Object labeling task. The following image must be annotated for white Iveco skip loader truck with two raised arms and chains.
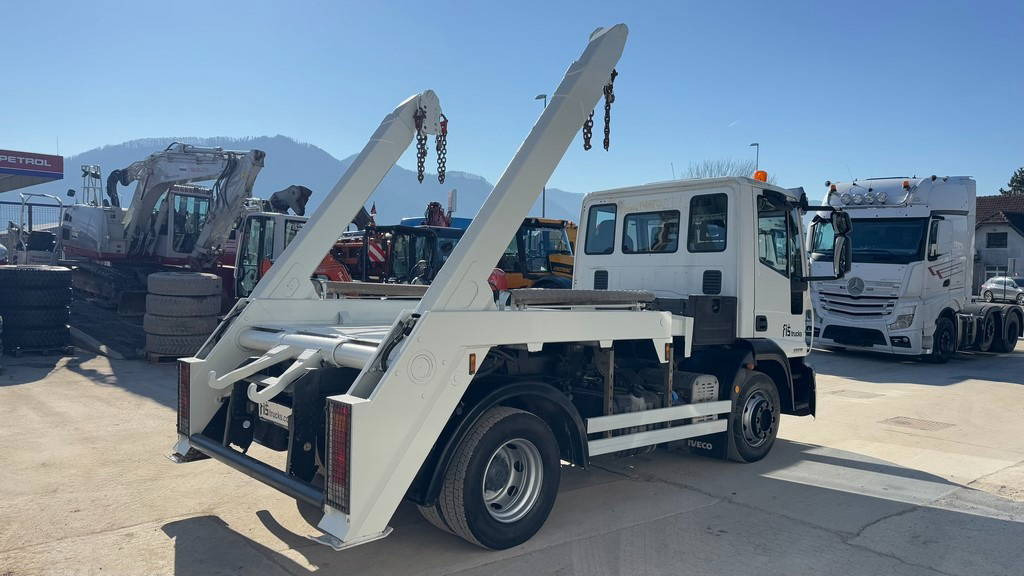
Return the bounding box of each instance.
[172,25,849,549]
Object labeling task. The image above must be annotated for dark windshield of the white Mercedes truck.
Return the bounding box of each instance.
[811,218,928,264]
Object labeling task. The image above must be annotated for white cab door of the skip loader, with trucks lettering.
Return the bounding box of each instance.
[754,191,808,355]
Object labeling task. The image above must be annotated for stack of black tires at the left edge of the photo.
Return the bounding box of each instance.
[0,265,72,354]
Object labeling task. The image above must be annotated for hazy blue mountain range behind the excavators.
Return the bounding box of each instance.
[0,135,583,223]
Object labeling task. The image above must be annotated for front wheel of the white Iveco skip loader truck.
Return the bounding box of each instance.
[729,370,781,462]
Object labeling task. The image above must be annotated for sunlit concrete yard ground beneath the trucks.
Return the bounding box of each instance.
[0,347,1024,576]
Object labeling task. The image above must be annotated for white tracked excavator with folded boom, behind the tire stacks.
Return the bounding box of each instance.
[61,142,311,312]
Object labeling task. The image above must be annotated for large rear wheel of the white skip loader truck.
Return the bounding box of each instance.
[438,406,561,550]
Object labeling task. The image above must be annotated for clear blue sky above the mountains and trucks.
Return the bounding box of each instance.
[0,0,1024,196]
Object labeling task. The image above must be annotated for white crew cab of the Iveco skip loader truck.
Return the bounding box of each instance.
[572,177,811,358]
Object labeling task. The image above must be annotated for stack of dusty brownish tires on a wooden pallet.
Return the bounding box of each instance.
[142,272,220,359]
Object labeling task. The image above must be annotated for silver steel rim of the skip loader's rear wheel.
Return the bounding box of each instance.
[480,438,544,524]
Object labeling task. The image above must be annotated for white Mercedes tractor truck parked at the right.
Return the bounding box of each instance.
[808,176,1024,362]
